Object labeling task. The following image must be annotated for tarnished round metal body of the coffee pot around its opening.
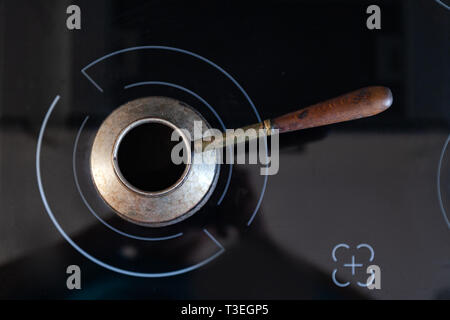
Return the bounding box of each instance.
[90,97,219,227]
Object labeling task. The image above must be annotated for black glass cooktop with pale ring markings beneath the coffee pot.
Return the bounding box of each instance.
[0,0,450,299]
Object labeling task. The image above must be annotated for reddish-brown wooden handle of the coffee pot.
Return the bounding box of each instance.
[271,87,392,133]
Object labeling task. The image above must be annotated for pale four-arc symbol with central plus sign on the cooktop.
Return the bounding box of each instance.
[331,243,381,289]
